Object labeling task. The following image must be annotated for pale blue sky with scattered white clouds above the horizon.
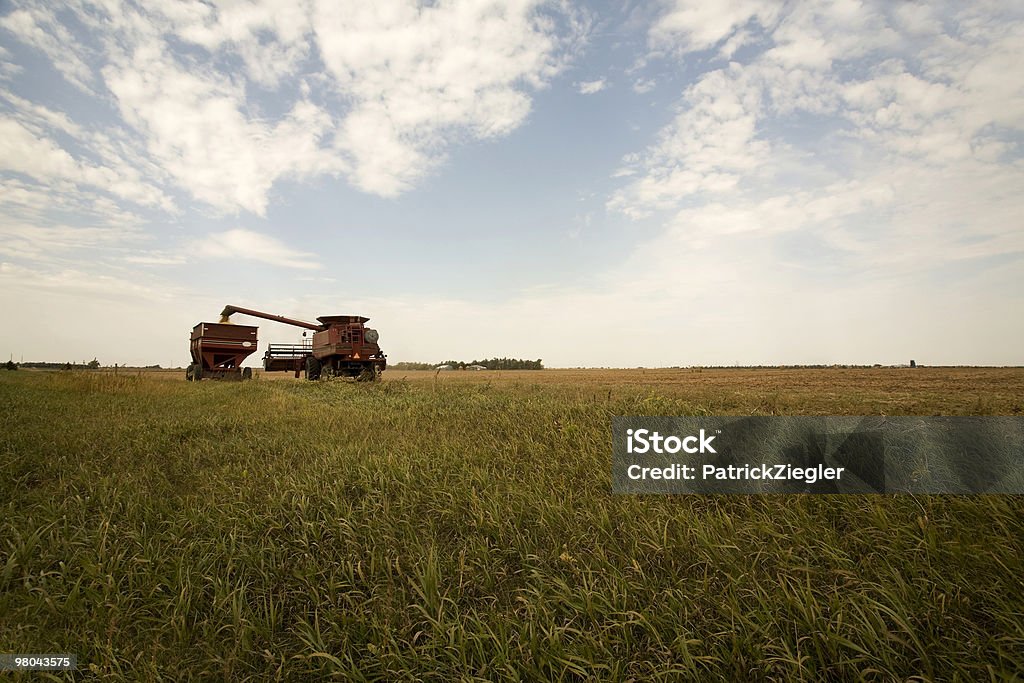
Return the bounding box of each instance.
[0,0,1024,368]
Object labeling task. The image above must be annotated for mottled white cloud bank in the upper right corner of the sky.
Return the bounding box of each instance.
[609,2,1024,223]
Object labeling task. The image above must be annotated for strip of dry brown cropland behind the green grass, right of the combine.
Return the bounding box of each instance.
[385,368,1024,415]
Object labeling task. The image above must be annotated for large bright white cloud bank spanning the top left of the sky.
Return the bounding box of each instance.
[0,0,586,215]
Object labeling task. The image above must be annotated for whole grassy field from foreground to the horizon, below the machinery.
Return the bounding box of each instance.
[0,368,1024,681]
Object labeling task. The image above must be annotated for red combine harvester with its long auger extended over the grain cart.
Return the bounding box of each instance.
[220,306,387,382]
